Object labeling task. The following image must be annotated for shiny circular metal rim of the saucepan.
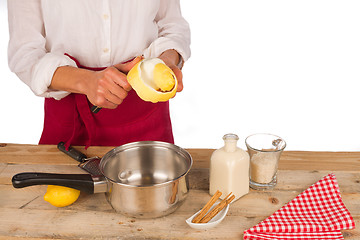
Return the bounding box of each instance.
[99,141,193,188]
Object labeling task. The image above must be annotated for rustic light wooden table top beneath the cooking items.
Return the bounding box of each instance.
[0,144,360,240]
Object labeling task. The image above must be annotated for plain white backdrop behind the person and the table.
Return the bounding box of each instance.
[0,0,360,151]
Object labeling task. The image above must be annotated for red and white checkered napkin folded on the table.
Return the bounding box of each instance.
[244,174,355,240]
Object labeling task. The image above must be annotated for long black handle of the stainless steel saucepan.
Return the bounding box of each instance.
[12,172,94,194]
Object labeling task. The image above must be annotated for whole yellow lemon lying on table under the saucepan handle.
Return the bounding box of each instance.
[44,185,80,207]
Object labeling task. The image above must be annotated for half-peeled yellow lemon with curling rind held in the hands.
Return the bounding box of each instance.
[127,58,178,103]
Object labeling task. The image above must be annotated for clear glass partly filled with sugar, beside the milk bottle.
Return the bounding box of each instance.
[245,133,286,190]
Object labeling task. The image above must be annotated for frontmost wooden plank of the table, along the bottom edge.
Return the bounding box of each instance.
[0,208,360,239]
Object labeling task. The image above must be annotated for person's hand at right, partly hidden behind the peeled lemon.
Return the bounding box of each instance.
[159,49,184,92]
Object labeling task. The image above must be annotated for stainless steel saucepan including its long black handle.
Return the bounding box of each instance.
[12,141,192,218]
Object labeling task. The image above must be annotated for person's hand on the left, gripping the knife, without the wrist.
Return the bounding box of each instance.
[85,57,141,109]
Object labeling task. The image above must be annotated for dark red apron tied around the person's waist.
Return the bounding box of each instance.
[39,56,174,148]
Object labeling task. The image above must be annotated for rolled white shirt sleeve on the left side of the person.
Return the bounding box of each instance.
[7,0,76,99]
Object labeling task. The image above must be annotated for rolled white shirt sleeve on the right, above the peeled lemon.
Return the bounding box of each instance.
[144,0,191,61]
